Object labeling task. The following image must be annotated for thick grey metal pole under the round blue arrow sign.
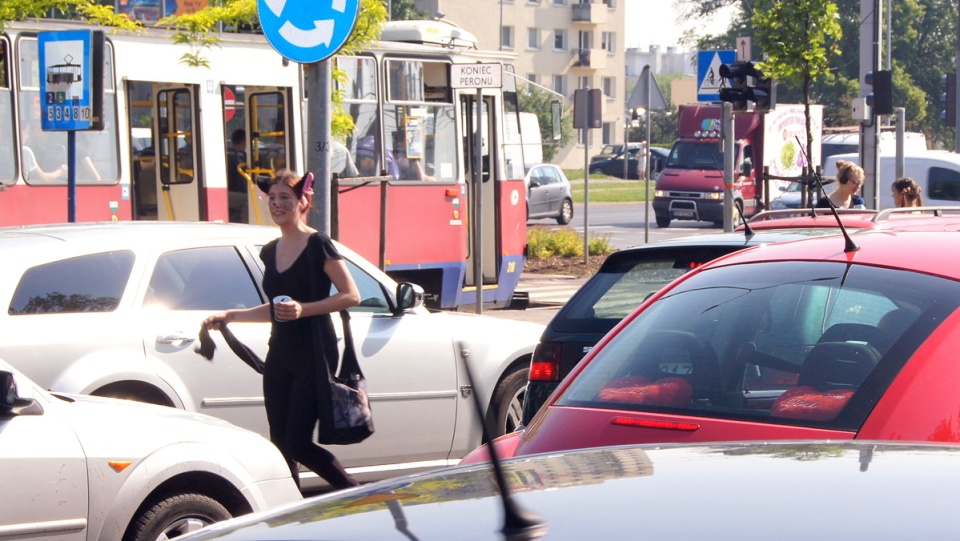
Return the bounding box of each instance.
[312,60,333,235]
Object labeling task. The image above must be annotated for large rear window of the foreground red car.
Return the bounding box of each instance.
[557,262,960,430]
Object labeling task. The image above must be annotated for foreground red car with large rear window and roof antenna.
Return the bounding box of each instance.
[464,230,960,462]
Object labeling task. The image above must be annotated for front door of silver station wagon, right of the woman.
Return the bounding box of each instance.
[333,260,465,467]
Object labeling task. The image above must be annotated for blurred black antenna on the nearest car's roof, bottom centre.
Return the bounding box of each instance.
[457,342,547,541]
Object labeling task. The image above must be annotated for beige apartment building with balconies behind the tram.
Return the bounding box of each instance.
[416,0,626,168]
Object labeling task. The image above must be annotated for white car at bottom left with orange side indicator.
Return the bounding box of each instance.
[0,361,301,541]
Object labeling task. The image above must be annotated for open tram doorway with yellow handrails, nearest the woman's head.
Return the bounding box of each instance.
[223,86,297,224]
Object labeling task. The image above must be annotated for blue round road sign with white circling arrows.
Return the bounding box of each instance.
[257,0,360,64]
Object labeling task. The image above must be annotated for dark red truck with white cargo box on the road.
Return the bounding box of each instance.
[653,104,823,227]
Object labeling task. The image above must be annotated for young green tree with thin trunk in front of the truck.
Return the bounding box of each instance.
[752,0,842,169]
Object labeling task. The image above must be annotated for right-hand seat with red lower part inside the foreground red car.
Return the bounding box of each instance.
[770,342,880,421]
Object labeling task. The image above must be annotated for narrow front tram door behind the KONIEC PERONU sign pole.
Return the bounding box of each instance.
[460,95,500,287]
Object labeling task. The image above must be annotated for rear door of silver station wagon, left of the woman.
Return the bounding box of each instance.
[139,242,270,435]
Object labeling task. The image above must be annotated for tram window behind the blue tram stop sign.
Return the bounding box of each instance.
[15,37,120,185]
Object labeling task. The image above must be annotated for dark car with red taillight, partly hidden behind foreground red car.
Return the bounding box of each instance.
[523,227,837,424]
